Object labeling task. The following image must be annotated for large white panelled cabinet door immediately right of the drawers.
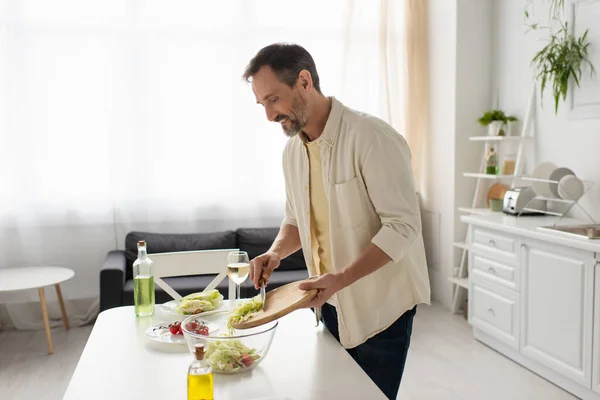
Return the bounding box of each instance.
[521,241,595,388]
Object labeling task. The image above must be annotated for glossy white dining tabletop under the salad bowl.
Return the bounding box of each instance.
[63,306,385,400]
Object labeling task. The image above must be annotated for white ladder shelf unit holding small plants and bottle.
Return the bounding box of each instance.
[448,83,536,314]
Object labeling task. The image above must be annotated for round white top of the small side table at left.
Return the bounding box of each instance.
[0,267,75,292]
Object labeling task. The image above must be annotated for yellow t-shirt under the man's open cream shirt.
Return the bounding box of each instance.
[306,139,335,305]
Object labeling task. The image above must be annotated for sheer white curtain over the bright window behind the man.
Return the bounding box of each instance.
[0,0,404,328]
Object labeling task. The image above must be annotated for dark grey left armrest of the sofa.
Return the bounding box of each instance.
[100,250,127,311]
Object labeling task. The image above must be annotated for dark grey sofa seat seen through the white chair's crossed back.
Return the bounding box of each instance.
[123,274,232,305]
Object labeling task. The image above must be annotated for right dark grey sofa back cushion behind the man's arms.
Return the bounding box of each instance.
[235,228,306,271]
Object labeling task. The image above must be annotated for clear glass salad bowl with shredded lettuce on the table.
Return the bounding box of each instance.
[181,313,278,374]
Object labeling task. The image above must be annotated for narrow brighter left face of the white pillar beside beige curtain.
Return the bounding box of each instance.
[422,0,456,304]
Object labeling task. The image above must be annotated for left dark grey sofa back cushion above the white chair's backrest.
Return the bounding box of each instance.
[125,231,238,279]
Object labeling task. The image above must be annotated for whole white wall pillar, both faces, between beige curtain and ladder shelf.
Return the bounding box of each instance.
[423,0,492,307]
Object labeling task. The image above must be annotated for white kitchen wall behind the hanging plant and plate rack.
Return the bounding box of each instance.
[493,0,600,221]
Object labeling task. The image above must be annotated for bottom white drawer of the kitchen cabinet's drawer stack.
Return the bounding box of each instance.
[469,284,519,349]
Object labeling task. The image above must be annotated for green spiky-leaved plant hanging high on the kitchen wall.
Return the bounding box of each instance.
[525,0,595,114]
